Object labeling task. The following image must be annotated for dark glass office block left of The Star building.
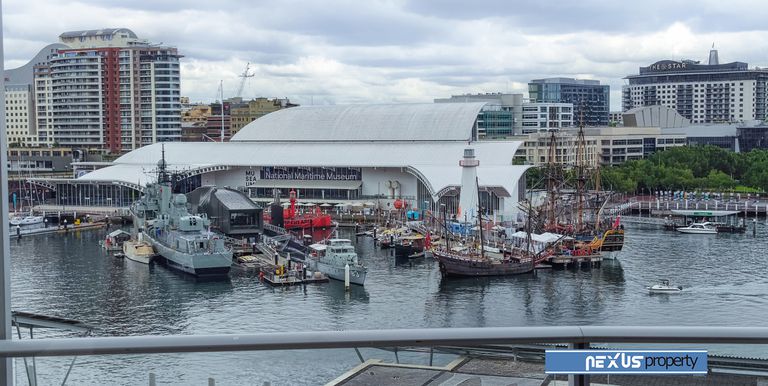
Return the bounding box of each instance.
[528,78,611,126]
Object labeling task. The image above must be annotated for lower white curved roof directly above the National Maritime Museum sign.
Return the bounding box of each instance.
[77,141,528,201]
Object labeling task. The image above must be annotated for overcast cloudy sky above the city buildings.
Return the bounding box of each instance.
[3,0,768,110]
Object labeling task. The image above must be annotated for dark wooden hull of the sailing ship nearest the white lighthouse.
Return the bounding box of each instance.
[433,251,533,277]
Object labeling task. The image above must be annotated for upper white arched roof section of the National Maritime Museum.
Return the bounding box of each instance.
[231,102,485,142]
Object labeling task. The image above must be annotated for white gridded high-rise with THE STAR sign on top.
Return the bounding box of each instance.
[621,49,768,123]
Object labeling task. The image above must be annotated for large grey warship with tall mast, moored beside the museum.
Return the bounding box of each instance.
[131,148,232,277]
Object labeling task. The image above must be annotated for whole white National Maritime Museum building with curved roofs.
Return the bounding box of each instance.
[35,103,529,218]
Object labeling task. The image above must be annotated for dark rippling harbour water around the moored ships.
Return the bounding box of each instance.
[11,223,768,385]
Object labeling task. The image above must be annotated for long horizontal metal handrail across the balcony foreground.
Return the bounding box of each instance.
[0,326,768,357]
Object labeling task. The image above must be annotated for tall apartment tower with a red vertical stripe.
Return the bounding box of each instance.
[24,28,181,153]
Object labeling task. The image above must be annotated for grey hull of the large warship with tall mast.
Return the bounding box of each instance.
[144,233,232,277]
